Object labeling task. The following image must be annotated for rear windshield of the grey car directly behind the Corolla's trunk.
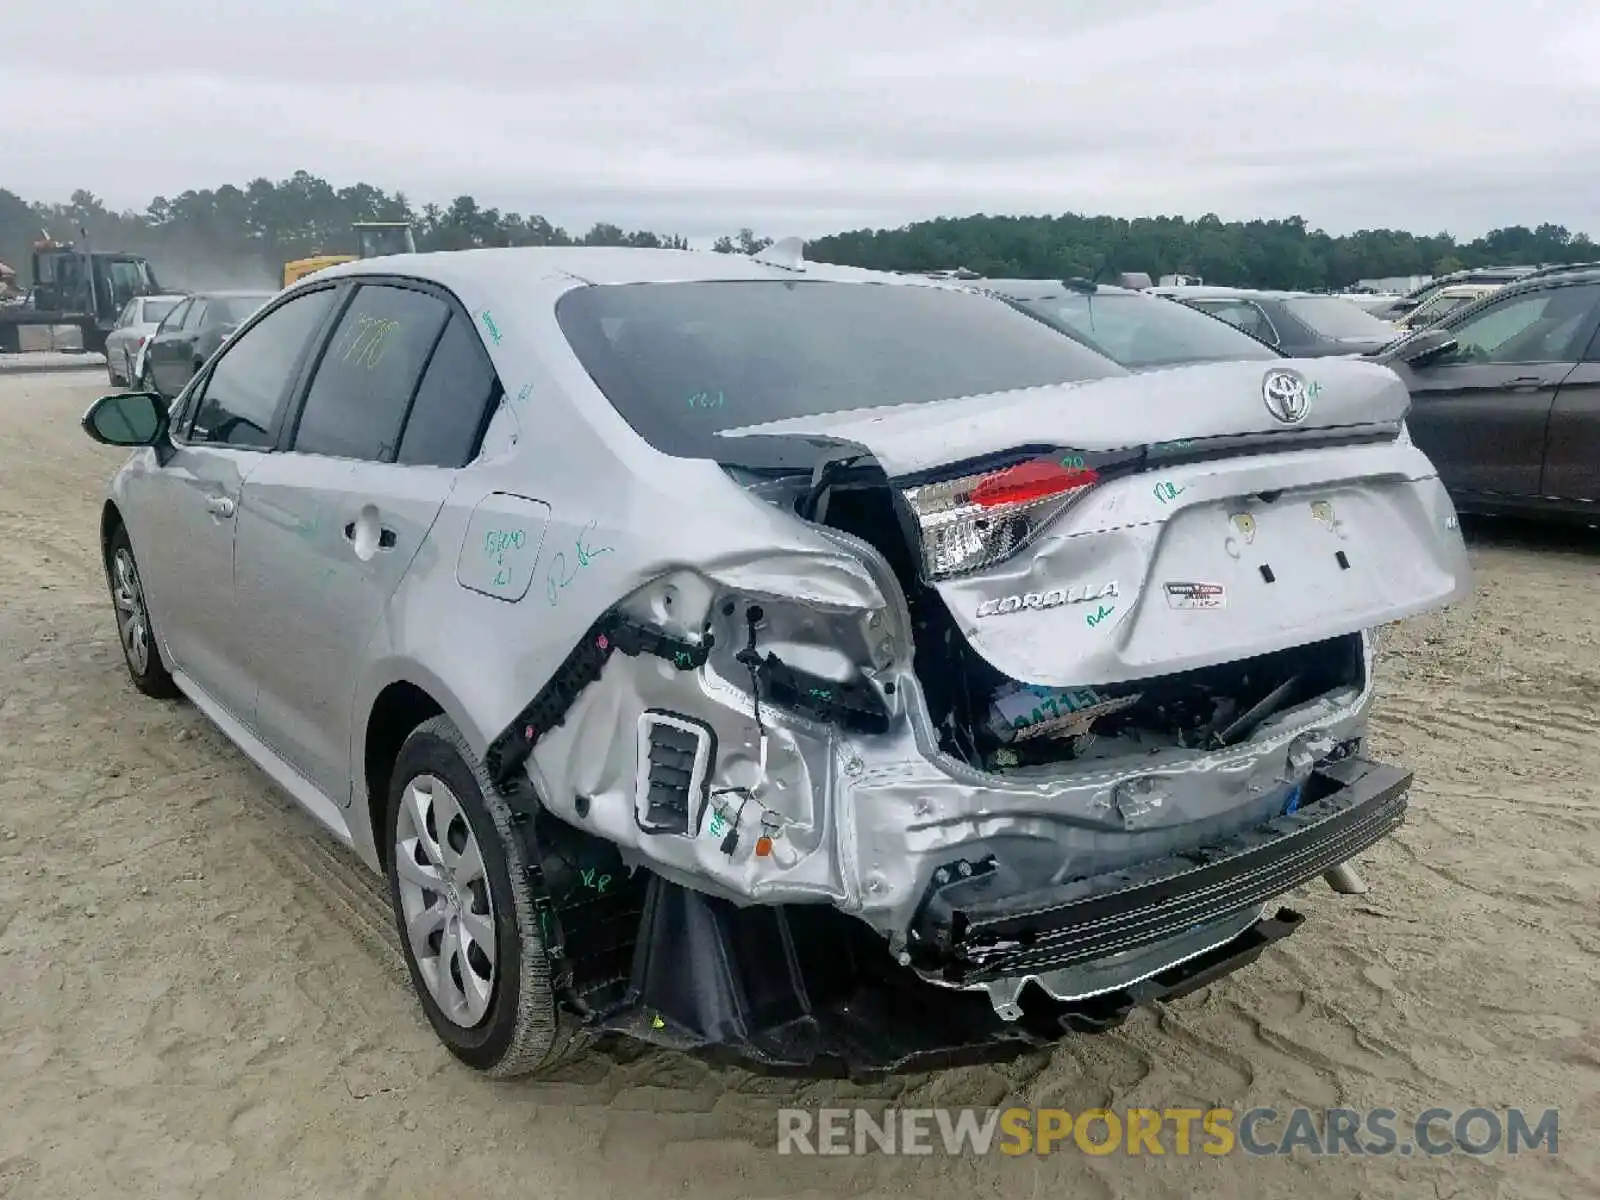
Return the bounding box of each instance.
[1019,293,1278,368]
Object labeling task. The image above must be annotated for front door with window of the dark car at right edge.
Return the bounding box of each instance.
[1395,285,1600,504]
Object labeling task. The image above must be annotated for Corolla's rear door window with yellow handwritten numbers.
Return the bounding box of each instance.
[293,285,450,462]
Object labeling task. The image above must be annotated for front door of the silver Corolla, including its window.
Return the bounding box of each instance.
[130,290,342,722]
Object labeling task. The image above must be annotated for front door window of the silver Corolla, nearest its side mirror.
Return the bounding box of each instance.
[189,288,334,450]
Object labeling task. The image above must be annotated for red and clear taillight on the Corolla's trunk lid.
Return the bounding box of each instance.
[902,454,1101,582]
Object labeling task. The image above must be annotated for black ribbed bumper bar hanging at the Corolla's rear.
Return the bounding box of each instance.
[909,758,1413,987]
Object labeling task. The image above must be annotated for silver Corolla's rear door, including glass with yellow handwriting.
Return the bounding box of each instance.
[237,280,496,805]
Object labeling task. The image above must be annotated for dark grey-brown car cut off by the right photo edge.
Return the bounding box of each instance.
[1378,267,1600,520]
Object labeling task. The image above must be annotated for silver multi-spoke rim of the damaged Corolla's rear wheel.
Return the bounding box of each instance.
[394,774,496,1029]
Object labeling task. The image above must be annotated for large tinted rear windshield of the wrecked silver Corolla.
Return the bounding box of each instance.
[555,280,1126,467]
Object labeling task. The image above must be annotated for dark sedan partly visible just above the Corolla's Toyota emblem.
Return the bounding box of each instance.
[1154,288,1395,358]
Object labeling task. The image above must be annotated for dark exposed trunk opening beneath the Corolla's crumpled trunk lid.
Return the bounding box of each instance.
[797,472,1363,771]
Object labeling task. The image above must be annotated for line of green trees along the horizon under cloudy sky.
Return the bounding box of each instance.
[0,171,1600,290]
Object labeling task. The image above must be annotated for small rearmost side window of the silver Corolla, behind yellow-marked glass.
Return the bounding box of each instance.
[395,314,499,467]
